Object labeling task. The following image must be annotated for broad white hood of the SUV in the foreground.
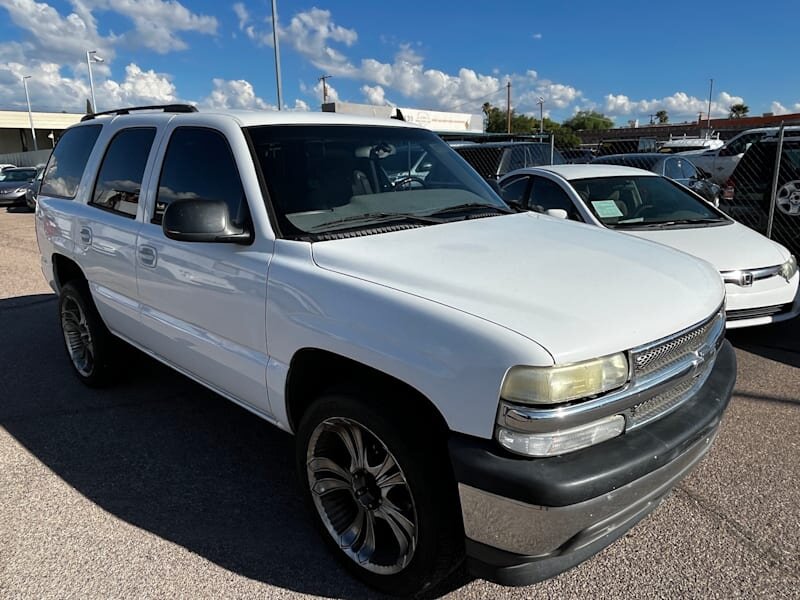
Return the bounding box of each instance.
[312,213,724,363]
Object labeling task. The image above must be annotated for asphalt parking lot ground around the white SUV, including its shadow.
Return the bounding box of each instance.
[0,207,800,600]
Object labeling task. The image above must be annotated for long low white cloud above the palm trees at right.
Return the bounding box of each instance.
[604,92,744,122]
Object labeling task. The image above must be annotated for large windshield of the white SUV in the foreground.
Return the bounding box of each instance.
[247,125,508,239]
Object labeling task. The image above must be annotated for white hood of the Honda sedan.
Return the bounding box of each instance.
[625,222,789,271]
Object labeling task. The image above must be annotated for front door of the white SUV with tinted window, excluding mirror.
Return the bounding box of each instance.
[136,124,273,413]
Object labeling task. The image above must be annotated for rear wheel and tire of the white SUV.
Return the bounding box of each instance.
[58,281,117,387]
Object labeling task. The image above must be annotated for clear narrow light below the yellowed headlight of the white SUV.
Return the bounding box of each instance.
[497,415,625,456]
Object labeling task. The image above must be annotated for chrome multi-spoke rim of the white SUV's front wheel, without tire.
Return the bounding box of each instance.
[306,417,417,575]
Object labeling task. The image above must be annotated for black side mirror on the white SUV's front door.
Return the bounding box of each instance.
[161,198,253,244]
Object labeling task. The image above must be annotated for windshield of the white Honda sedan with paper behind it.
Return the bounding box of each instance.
[570,176,730,229]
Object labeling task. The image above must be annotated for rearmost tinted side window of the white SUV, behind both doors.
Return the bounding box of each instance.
[40,125,102,199]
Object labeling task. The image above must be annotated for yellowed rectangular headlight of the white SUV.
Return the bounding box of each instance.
[500,352,628,404]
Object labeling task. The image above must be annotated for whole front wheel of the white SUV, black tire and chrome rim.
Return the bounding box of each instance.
[296,390,464,596]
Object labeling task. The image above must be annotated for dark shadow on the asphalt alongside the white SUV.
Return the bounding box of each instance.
[0,294,466,598]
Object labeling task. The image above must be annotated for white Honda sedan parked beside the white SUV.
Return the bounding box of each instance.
[499,165,800,329]
